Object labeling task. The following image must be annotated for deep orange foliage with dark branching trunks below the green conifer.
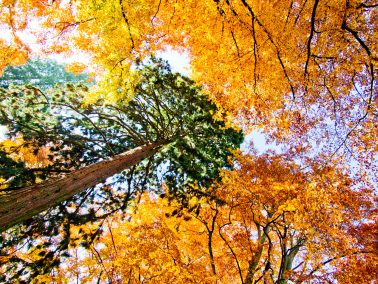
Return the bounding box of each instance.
[36,150,378,283]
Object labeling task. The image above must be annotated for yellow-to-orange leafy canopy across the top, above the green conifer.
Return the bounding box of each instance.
[2,0,378,166]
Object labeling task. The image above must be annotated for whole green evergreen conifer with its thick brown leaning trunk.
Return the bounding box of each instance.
[0,59,243,281]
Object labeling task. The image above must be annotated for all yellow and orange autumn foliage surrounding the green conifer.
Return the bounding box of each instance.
[0,0,378,283]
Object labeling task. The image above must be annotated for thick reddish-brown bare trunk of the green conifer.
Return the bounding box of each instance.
[0,142,164,232]
